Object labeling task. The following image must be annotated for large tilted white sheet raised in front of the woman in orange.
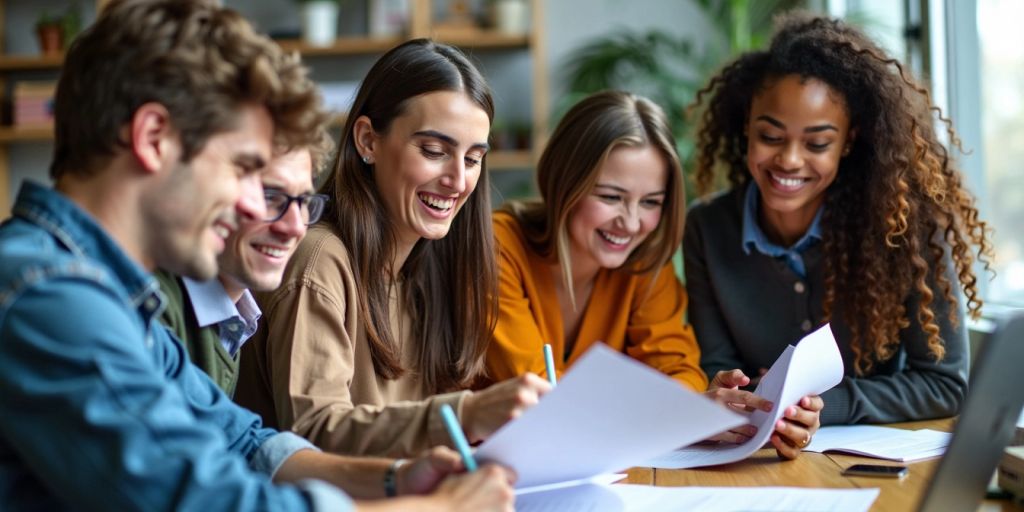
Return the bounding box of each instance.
[476,344,745,487]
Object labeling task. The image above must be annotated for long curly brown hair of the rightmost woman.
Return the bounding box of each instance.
[690,12,992,375]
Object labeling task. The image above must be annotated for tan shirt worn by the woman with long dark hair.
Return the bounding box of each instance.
[234,225,468,457]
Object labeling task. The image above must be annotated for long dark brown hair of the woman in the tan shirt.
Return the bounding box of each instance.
[321,39,498,393]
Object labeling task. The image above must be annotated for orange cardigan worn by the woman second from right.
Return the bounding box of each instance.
[486,212,708,391]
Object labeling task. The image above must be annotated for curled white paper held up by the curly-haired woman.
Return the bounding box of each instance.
[645,324,844,469]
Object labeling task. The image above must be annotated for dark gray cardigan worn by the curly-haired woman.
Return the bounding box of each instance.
[683,186,969,425]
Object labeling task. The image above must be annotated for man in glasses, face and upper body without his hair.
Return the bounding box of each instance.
[157,145,329,396]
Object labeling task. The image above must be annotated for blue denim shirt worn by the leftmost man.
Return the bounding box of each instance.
[0,183,351,512]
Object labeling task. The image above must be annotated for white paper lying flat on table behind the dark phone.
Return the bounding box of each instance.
[804,425,953,462]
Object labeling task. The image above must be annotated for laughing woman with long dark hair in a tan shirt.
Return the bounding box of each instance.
[237,39,549,457]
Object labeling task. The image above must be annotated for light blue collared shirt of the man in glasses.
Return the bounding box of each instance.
[181,278,263,356]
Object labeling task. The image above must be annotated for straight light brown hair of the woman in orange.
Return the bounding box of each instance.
[504,90,686,306]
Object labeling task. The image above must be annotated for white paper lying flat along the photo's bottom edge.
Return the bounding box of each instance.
[515,484,879,512]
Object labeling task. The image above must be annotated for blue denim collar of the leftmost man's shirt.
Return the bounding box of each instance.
[12,180,166,319]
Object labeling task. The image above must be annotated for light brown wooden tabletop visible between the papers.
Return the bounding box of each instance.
[625,419,1024,512]
